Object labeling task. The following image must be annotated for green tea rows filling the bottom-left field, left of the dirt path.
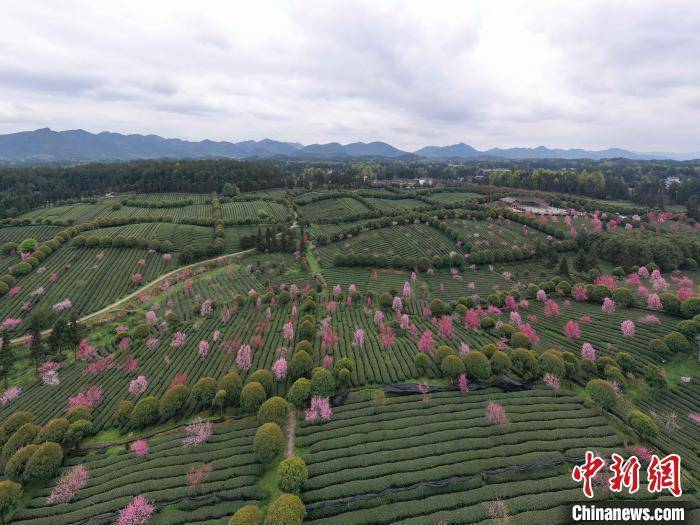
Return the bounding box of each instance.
[13,418,267,525]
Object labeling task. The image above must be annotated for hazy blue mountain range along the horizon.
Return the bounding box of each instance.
[0,128,700,163]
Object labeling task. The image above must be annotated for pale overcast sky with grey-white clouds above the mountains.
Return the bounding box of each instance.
[0,0,700,151]
